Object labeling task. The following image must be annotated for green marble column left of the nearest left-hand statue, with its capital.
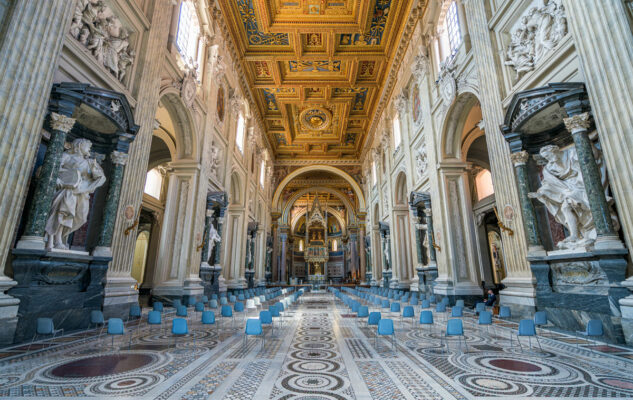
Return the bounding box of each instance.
[24,112,75,237]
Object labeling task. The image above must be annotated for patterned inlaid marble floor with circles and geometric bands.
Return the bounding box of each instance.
[0,294,633,400]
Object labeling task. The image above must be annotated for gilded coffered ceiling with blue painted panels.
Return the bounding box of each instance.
[219,0,412,160]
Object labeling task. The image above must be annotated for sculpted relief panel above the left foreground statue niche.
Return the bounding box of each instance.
[69,0,136,82]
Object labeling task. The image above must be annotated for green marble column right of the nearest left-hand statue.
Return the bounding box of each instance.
[92,150,128,257]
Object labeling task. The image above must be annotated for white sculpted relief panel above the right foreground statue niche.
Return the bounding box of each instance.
[505,0,567,79]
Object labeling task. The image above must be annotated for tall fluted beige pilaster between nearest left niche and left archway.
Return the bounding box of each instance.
[104,0,172,317]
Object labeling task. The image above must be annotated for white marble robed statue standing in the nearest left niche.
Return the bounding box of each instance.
[46,139,106,250]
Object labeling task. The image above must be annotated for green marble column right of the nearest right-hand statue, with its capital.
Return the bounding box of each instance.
[564,112,615,237]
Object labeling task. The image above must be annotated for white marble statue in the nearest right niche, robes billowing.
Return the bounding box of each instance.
[528,145,596,249]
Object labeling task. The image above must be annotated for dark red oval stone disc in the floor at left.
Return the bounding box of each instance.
[50,353,155,378]
